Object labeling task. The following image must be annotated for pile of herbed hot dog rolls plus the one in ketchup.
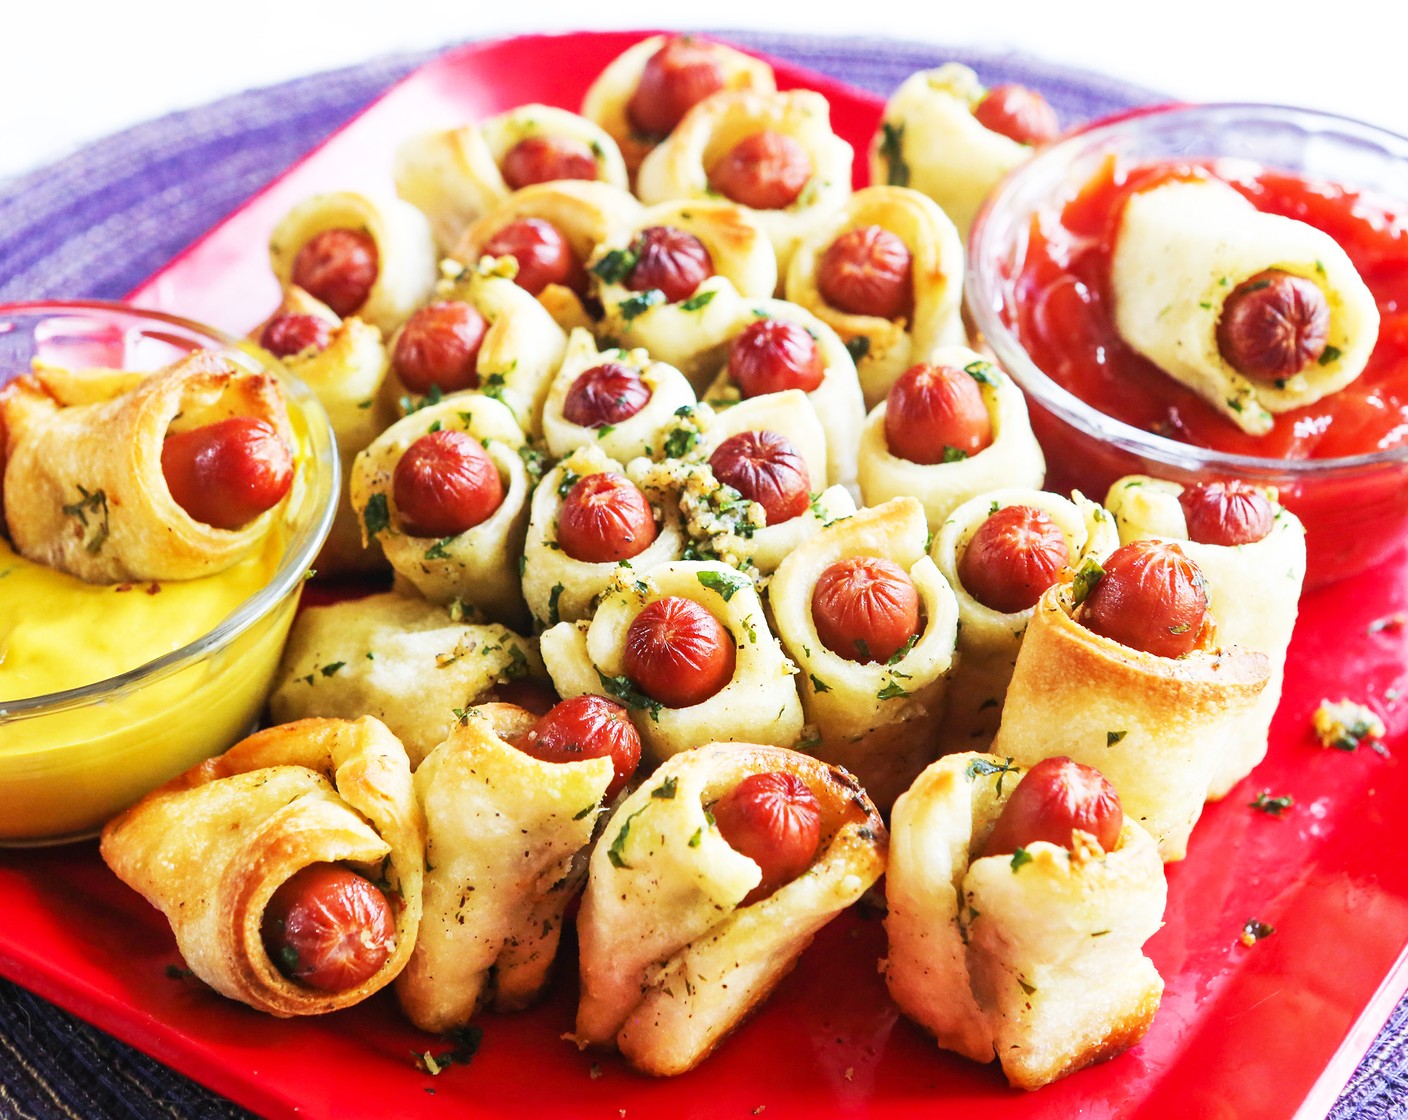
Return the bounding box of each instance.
[74,37,1373,1089]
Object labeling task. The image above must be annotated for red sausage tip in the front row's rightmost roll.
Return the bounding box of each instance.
[983,757,1125,855]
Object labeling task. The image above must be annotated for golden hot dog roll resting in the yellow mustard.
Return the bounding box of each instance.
[0,351,298,583]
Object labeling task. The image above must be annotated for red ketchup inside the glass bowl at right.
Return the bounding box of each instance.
[1004,158,1408,585]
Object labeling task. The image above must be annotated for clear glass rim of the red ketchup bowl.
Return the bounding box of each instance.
[963,101,1408,485]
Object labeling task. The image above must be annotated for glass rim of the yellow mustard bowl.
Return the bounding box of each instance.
[0,300,341,718]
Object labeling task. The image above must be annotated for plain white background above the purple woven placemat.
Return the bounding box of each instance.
[0,0,1408,180]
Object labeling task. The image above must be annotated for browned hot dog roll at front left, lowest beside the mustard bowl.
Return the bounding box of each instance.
[101,717,425,1016]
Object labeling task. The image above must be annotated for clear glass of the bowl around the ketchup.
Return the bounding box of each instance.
[964,104,1408,586]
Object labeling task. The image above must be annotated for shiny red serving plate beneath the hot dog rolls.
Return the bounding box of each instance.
[0,32,1408,1120]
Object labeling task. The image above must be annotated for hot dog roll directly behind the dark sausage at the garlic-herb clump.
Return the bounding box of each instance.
[704,300,865,490]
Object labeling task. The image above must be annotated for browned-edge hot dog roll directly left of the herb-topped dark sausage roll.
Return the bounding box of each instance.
[451,179,641,331]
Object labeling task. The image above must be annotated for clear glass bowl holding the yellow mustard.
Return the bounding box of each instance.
[0,301,338,847]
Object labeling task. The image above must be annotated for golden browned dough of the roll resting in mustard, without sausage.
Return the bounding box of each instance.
[0,351,297,583]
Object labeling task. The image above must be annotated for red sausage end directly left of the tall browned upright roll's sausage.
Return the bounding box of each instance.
[959,506,1070,614]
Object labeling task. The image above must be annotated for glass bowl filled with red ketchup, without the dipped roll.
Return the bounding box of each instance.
[966,106,1408,586]
